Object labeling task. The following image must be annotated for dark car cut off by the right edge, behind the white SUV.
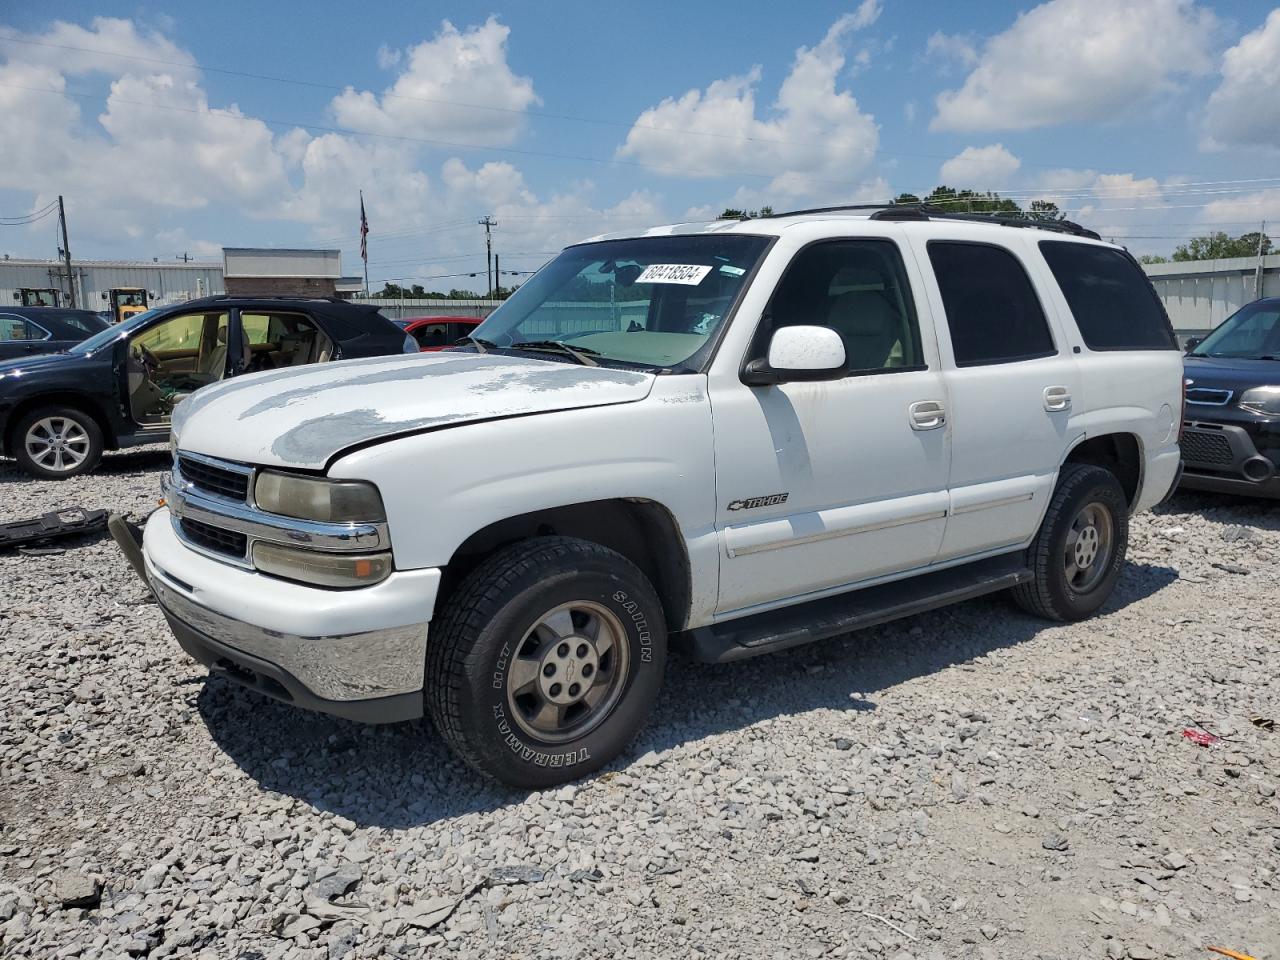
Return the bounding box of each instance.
[1181,297,1280,498]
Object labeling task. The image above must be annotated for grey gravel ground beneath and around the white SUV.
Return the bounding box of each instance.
[0,451,1280,960]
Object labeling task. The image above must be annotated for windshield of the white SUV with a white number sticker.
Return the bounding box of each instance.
[471,234,769,371]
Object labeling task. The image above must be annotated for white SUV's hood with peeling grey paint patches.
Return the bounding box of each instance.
[173,353,654,470]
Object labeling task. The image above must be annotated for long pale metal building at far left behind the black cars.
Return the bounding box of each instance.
[0,257,224,310]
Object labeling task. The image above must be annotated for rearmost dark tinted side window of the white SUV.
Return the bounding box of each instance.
[1039,241,1178,349]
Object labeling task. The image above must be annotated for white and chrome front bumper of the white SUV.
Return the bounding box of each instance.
[142,509,440,723]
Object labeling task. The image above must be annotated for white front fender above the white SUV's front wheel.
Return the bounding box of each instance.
[329,375,718,586]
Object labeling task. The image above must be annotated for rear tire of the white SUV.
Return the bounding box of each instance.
[1014,463,1129,621]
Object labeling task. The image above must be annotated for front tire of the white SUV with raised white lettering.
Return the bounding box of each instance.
[424,536,667,787]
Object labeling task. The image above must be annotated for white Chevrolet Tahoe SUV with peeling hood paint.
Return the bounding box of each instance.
[114,207,1183,786]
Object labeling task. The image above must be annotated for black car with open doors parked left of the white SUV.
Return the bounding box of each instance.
[0,297,417,480]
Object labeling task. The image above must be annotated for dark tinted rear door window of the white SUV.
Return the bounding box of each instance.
[929,241,1057,366]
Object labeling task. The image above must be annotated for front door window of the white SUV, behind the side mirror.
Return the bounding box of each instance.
[753,239,925,375]
